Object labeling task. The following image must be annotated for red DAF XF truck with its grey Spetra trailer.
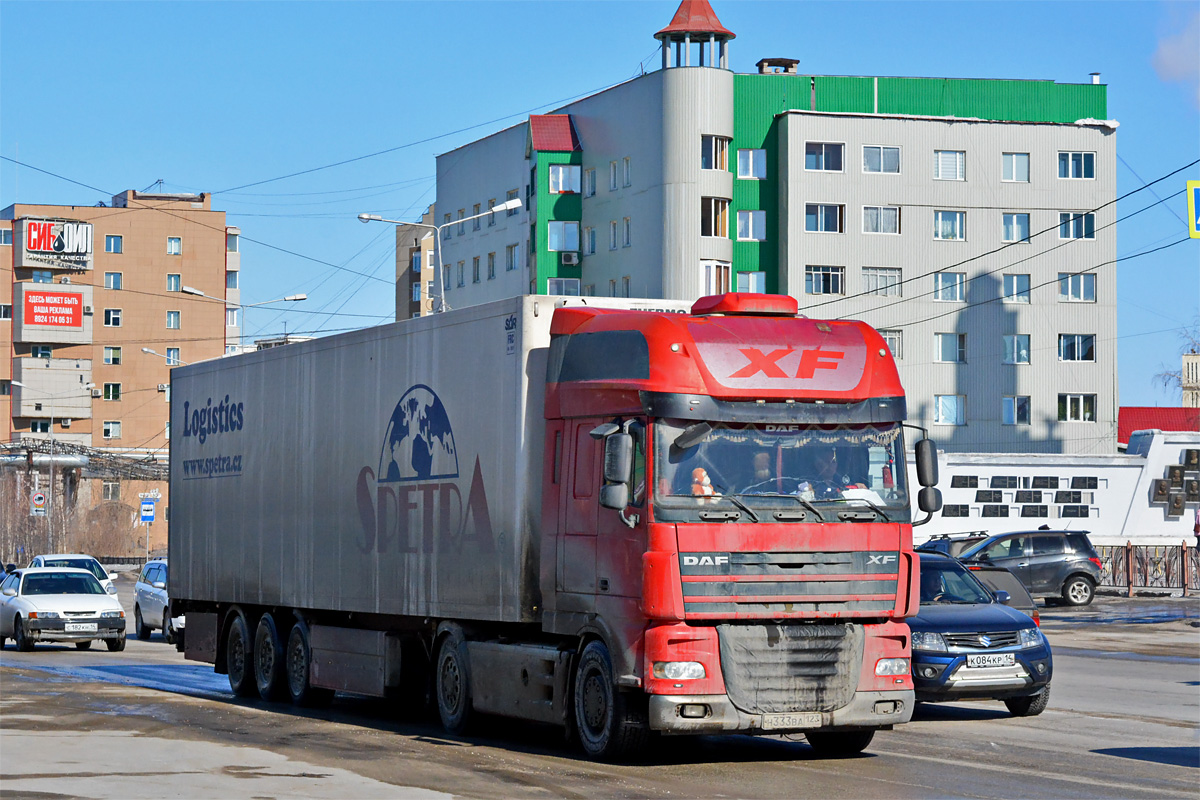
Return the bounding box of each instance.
[169,294,941,758]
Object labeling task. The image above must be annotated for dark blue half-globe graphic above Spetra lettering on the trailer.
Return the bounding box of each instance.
[378,385,458,483]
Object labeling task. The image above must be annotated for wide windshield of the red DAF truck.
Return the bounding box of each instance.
[654,420,910,522]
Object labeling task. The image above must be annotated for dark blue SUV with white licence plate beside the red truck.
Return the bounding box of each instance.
[908,553,1054,716]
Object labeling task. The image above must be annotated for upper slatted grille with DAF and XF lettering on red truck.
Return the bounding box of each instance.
[679,552,899,619]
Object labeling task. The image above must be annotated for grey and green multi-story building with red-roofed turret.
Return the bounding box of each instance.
[437,0,1117,452]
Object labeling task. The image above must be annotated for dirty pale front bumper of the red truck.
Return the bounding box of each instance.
[649,690,913,734]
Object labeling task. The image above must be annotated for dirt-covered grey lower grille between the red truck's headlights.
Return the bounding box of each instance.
[716,622,864,714]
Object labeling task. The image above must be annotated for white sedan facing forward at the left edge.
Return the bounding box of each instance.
[0,567,125,651]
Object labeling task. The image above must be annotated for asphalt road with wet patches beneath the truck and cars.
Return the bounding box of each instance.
[0,582,1200,799]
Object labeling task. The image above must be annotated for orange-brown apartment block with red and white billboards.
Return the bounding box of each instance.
[0,191,241,458]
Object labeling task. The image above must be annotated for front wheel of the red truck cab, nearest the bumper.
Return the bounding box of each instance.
[575,640,650,760]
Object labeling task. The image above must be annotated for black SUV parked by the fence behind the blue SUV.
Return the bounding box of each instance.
[959,530,1100,606]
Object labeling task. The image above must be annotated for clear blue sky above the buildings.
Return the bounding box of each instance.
[0,0,1200,405]
